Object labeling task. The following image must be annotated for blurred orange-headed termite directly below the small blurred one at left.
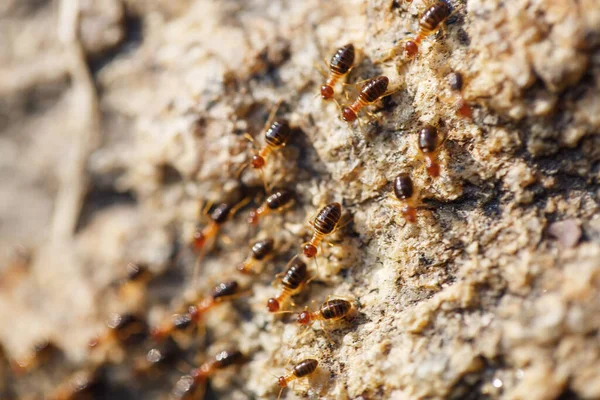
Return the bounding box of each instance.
[88,313,148,349]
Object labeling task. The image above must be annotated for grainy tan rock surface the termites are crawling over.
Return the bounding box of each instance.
[0,0,600,399]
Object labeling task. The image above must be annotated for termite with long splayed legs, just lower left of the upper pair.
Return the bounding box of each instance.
[237,101,292,193]
